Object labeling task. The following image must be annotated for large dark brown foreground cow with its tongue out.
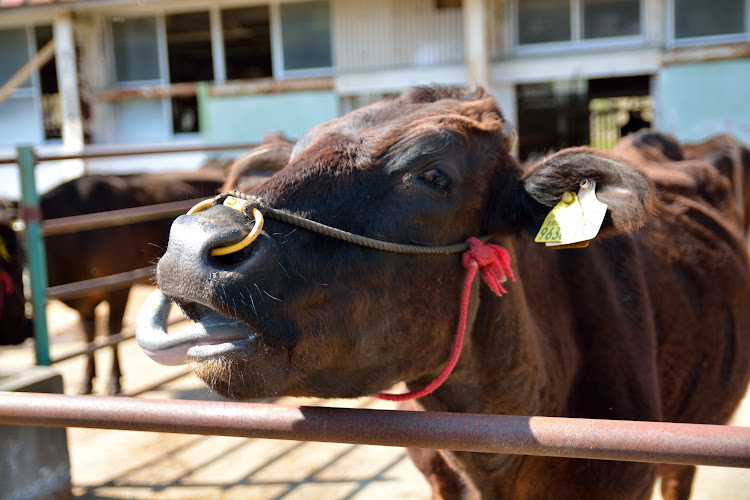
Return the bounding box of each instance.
[136,88,750,499]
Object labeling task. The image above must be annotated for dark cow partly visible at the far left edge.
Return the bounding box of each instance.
[0,211,33,345]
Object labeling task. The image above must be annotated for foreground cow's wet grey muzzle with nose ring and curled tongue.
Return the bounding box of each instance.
[136,200,263,365]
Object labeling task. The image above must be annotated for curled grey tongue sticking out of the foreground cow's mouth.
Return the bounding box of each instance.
[135,290,249,365]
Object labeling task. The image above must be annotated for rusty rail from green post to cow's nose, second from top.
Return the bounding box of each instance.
[42,197,208,236]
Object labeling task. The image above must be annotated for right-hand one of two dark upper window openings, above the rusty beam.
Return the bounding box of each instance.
[221,6,273,80]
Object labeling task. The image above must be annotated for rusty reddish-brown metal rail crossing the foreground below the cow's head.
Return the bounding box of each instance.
[0,393,750,468]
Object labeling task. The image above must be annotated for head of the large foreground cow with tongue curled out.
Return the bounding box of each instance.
[138,88,650,398]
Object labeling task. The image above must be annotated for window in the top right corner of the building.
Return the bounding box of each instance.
[674,0,747,38]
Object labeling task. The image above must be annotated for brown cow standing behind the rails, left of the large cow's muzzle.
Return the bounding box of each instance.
[41,171,223,394]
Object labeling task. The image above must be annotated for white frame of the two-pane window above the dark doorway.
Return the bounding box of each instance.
[510,0,648,55]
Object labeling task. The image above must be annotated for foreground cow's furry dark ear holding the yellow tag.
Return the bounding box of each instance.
[490,148,654,236]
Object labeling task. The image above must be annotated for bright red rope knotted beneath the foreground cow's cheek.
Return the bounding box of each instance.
[375,238,516,401]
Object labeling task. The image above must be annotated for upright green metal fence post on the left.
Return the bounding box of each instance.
[16,146,50,365]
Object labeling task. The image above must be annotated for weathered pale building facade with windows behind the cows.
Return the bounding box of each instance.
[0,0,750,196]
